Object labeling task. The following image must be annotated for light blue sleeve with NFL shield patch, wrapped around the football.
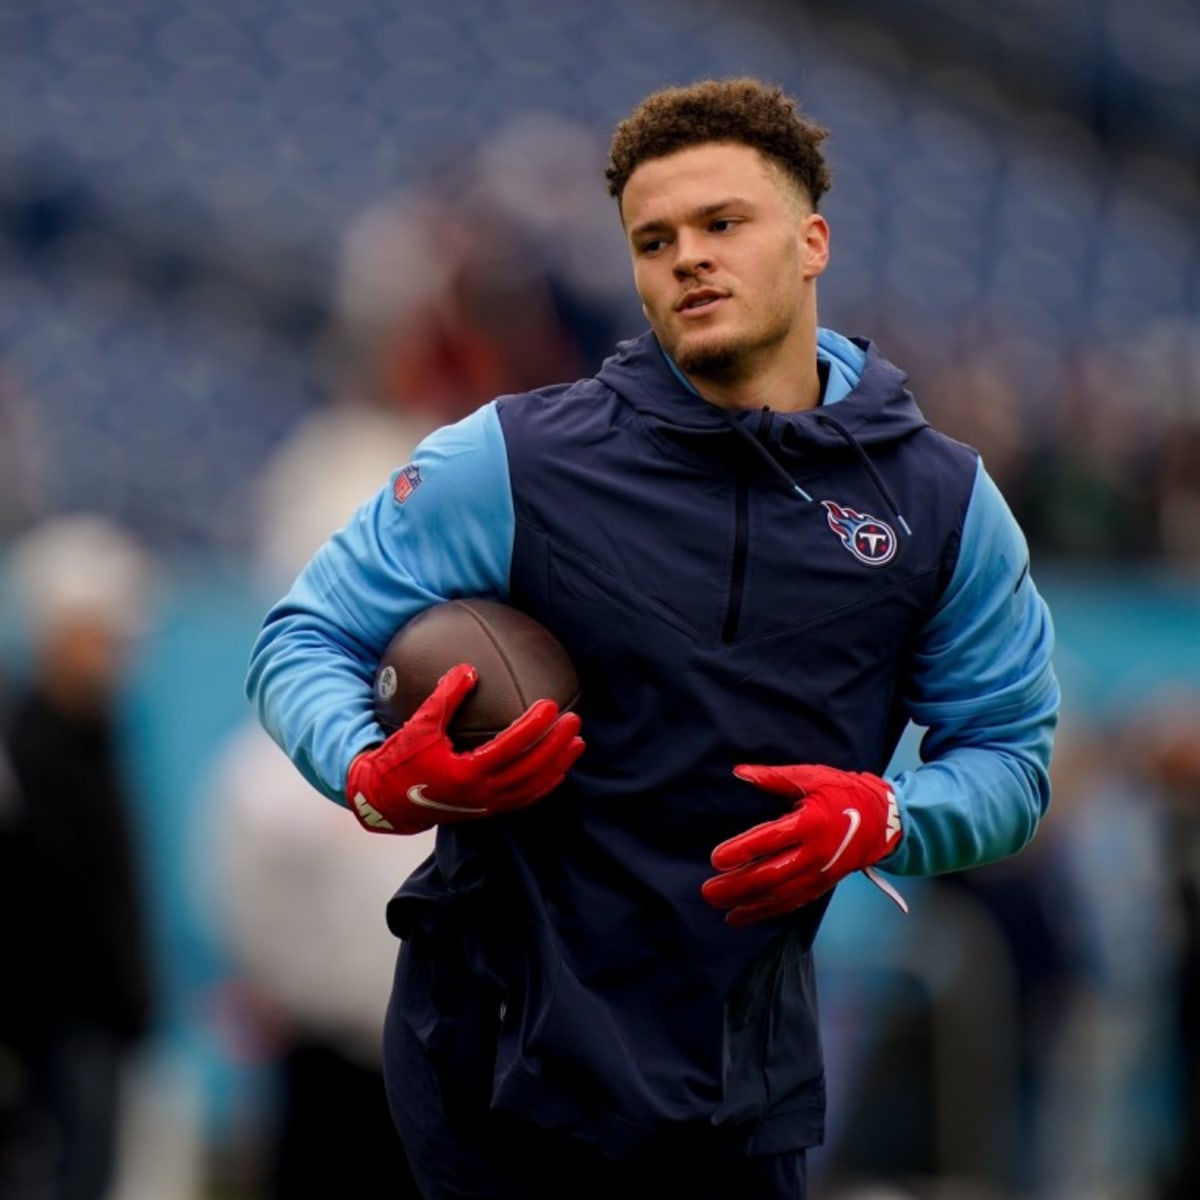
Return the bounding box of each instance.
[246,403,514,804]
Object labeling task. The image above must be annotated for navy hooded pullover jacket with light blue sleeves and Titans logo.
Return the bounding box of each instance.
[247,330,1058,1158]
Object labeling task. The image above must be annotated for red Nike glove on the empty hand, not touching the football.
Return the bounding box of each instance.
[701,764,907,925]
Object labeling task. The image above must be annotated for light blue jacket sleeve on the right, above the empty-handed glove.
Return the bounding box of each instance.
[880,463,1060,875]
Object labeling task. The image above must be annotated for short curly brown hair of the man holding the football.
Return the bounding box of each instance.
[605,78,833,209]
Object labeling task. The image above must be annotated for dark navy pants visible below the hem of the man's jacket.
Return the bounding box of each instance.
[385,954,806,1200]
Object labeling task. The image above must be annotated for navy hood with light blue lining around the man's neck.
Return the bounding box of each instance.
[598,329,928,458]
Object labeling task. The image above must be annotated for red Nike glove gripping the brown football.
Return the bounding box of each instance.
[346,662,583,833]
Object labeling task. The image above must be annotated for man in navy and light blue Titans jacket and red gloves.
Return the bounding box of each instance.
[247,79,1058,1200]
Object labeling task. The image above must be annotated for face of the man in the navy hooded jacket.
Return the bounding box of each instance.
[622,142,829,382]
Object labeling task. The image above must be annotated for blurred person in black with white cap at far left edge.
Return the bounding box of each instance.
[0,515,152,1200]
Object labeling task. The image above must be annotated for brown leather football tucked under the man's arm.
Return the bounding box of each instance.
[374,598,580,750]
